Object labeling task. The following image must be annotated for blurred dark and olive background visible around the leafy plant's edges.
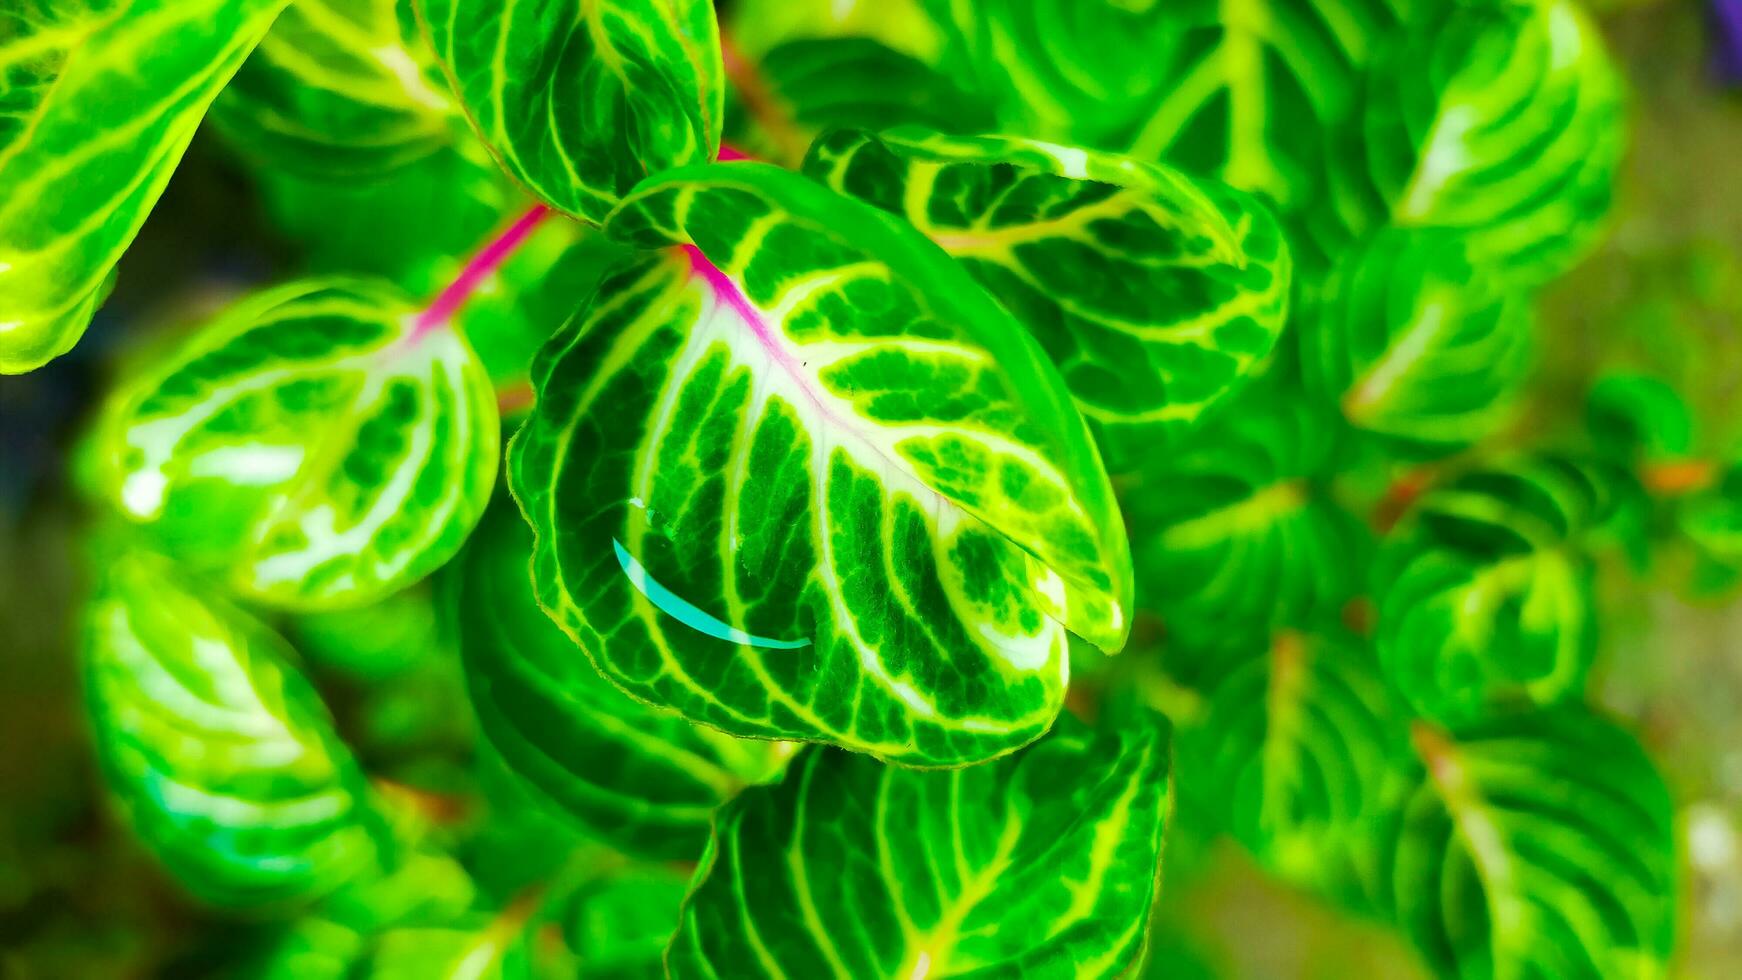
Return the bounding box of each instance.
[0,0,1742,980]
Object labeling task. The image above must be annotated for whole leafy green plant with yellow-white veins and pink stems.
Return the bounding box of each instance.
[0,0,1742,978]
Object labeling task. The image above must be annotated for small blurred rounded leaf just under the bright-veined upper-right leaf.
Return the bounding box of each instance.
[1301,232,1533,454]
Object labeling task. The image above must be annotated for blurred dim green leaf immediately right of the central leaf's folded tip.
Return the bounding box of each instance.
[1122,381,1371,635]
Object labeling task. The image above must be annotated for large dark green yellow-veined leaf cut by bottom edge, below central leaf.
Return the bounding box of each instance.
[665,715,1171,980]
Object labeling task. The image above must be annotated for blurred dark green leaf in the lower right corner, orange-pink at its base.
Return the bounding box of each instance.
[1387,708,1678,980]
